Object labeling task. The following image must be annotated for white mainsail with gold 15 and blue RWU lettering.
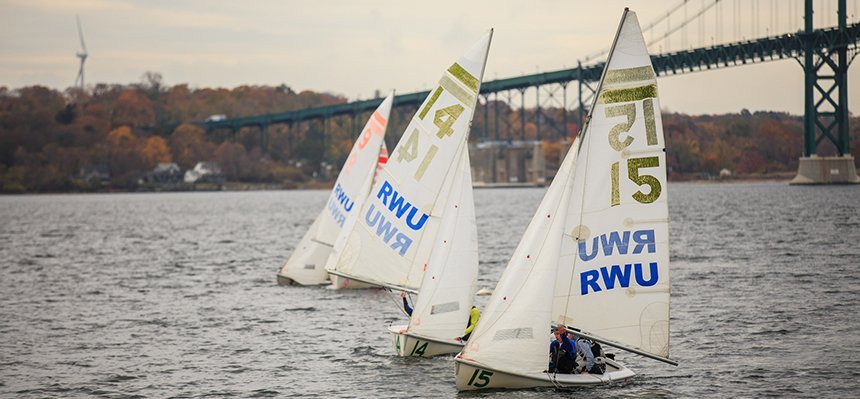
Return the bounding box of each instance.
[552,12,669,358]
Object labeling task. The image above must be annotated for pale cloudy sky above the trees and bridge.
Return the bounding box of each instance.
[0,0,860,114]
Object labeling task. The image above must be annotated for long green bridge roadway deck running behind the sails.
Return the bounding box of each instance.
[203,23,860,131]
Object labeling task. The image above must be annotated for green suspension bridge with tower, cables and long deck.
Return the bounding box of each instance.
[205,0,860,184]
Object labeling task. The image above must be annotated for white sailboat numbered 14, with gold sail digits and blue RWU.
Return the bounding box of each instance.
[326,30,492,357]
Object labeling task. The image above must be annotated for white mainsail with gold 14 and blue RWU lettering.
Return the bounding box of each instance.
[326,31,492,292]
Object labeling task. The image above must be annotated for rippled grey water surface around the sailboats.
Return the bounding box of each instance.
[0,183,860,398]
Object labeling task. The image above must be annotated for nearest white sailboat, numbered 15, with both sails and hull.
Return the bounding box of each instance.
[455,9,677,390]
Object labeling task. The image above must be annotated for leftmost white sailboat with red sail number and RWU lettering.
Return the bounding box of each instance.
[278,93,394,285]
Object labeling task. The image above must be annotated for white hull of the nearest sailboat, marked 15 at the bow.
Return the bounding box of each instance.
[454,357,636,391]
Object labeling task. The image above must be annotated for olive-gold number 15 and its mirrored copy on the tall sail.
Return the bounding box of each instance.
[605,98,663,206]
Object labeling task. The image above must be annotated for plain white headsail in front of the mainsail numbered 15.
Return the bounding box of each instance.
[460,138,579,372]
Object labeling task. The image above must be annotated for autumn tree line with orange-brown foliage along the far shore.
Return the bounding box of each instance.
[0,73,860,193]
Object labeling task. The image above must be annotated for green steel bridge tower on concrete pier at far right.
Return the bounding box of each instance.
[791,0,860,184]
